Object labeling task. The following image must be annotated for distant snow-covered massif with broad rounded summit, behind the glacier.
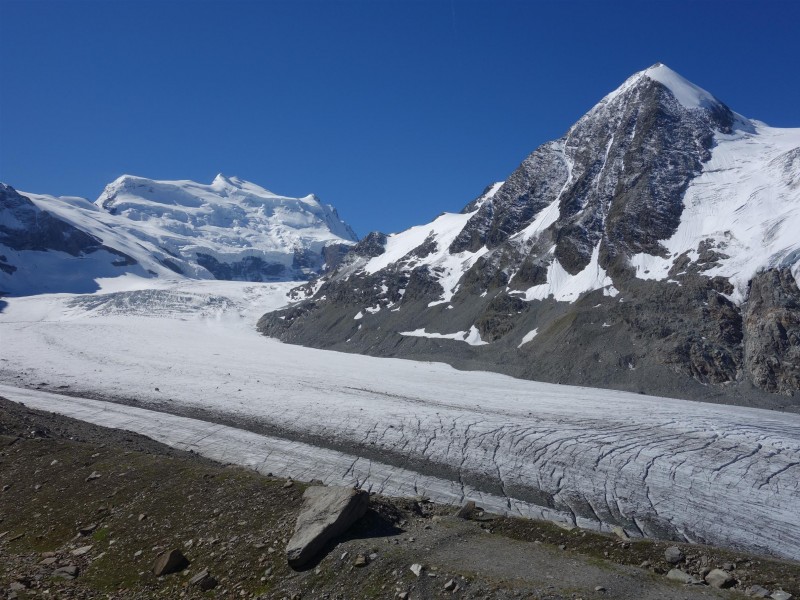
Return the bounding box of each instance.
[0,175,357,294]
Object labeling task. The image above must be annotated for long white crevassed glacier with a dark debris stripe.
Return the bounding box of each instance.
[0,281,800,559]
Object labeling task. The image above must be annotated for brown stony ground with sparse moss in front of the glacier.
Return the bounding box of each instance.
[0,398,800,600]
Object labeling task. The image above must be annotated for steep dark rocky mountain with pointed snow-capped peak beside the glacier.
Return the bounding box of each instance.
[259,64,800,406]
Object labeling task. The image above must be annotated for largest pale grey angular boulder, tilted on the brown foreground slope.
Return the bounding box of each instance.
[286,486,369,569]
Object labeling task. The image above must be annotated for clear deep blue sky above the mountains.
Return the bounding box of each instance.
[0,0,800,235]
